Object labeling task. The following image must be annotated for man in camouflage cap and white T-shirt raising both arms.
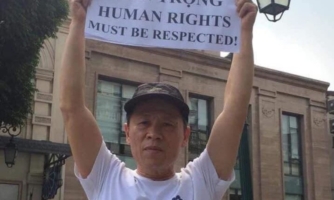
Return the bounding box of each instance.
[60,0,257,200]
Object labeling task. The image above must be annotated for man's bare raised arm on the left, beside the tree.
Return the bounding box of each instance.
[60,0,102,178]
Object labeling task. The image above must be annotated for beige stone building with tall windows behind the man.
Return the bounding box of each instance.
[0,17,332,200]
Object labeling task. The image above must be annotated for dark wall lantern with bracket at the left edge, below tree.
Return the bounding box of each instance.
[0,123,21,168]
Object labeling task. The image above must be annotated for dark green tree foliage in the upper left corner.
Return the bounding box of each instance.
[0,0,68,126]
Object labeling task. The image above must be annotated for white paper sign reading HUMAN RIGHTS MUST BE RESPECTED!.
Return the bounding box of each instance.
[85,0,240,52]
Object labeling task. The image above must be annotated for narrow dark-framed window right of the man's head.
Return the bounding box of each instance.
[188,97,210,161]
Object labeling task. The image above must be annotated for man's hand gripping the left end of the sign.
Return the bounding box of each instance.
[70,0,92,23]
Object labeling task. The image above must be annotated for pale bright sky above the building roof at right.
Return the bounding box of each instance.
[221,0,334,91]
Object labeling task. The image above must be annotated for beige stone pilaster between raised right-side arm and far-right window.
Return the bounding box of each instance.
[258,88,283,200]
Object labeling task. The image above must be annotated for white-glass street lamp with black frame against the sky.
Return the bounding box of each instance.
[257,0,291,22]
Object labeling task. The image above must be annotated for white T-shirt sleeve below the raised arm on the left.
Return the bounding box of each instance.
[74,142,121,200]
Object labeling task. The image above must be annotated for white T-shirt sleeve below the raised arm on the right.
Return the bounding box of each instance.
[186,149,235,200]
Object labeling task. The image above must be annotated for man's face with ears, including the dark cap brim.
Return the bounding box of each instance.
[124,99,190,173]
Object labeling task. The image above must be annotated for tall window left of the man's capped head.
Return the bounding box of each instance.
[96,80,136,169]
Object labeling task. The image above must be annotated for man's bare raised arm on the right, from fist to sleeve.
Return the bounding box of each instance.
[207,0,257,180]
